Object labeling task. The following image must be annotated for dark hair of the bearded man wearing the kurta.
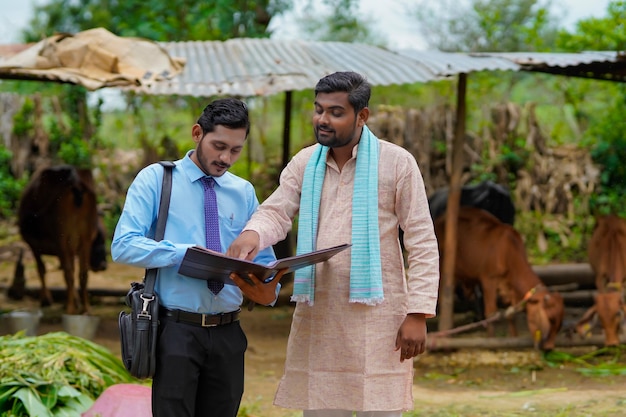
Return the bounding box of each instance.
[315,71,372,114]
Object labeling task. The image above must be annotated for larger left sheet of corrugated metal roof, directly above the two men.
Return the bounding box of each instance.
[140,38,442,97]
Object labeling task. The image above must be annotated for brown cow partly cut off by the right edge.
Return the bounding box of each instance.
[576,215,626,346]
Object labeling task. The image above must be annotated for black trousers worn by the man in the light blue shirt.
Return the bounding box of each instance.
[152,317,248,417]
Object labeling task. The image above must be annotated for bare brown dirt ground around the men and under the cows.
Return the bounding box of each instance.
[0,252,626,417]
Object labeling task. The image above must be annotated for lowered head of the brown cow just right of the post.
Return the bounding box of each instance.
[526,288,565,351]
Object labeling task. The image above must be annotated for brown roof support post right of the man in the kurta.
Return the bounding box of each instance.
[438,73,467,330]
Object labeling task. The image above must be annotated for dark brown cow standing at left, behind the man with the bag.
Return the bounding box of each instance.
[18,165,107,314]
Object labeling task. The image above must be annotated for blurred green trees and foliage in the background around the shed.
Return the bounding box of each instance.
[0,0,626,263]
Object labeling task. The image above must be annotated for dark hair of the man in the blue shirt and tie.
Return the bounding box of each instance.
[196,98,250,136]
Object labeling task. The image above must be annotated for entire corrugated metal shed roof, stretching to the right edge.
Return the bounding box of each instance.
[0,33,626,97]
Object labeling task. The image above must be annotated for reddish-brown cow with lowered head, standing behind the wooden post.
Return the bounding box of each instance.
[435,207,564,350]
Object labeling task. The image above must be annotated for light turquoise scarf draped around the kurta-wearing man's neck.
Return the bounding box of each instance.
[291,126,383,305]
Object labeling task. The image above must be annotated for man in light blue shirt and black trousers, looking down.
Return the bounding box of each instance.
[111,98,276,417]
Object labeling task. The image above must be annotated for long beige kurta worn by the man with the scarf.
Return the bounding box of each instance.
[241,136,439,411]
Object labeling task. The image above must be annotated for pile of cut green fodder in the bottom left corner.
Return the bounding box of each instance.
[0,332,138,417]
